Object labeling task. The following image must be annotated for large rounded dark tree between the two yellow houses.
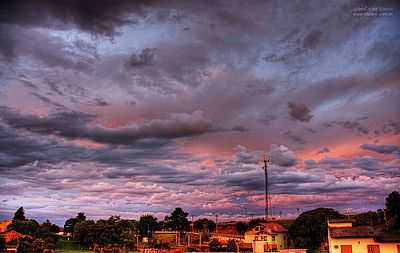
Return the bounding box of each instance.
[289,208,344,250]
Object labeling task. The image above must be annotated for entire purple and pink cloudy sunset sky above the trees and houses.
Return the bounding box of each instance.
[0,0,400,224]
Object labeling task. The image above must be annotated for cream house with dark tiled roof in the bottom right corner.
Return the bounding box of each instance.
[328,220,400,253]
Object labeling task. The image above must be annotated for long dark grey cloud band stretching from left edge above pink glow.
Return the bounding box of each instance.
[1,108,228,144]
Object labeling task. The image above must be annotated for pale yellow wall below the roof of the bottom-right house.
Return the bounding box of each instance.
[329,238,400,253]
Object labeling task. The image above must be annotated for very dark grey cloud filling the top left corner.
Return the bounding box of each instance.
[0,0,154,36]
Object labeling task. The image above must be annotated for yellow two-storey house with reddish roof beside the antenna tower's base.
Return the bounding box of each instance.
[244,222,288,252]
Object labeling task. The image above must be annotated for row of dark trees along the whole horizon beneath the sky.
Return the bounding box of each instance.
[0,191,400,253]
